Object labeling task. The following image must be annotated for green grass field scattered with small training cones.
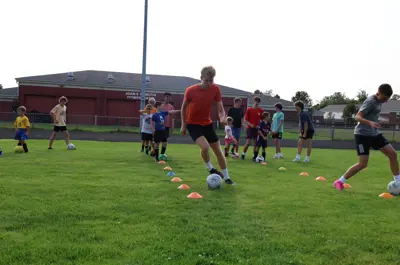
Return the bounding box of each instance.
[0,140,400,265]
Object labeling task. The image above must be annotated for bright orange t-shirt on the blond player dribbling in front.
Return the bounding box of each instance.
[184,84,222,126]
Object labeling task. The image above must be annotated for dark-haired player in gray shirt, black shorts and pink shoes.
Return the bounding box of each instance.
[333,84,400,190]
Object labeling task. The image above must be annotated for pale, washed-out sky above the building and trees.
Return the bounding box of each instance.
[0,0,400,102]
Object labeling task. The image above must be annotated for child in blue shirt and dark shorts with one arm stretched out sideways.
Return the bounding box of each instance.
[151,102,180,161]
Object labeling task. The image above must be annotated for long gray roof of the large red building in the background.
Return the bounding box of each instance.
[16,70,251,96]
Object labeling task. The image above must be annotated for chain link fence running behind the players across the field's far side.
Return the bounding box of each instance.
[0,112,400,142]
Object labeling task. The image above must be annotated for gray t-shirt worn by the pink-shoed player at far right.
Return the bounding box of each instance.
[354,95,382,136]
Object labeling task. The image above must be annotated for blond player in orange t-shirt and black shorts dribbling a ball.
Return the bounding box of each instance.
[181,66,235,184]
